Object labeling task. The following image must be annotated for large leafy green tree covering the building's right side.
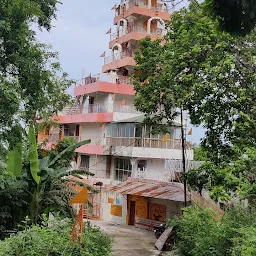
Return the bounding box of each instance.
[135,2,256,164]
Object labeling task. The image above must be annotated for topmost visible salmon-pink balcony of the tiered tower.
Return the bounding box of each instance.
[114,0,173,25]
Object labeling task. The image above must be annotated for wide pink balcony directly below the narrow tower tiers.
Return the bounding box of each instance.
[74,73,135,97]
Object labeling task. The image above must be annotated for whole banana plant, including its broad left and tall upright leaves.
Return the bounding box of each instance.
[0,125,96,223]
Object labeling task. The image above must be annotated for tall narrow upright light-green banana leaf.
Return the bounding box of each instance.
[29,125,40,184]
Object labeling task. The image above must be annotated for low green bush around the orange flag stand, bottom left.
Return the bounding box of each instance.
[0,219,112,256]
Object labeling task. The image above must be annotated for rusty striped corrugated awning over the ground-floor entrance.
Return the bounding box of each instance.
[108,178,190,202]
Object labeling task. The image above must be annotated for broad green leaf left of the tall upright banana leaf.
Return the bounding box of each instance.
[6,142,22,176]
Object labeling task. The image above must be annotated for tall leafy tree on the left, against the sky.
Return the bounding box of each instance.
[0,0,71,147]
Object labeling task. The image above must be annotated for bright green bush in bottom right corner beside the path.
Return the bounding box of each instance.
[170,206,256,256]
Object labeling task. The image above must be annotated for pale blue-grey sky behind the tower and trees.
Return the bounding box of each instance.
[37,0,204,143]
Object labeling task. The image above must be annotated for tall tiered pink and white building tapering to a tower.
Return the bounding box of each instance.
[40,0,196,228]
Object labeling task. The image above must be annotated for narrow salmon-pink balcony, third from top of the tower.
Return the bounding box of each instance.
[102,51,136,73]
